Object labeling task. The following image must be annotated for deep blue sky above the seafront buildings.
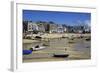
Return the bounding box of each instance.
[23,10,91,25]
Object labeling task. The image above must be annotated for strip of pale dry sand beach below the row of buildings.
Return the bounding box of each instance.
[23,33,91,43]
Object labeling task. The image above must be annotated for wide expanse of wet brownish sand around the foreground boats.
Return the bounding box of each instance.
[23,33,91,63]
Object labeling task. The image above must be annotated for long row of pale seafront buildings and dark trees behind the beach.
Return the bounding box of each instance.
[23,21,91,35]
